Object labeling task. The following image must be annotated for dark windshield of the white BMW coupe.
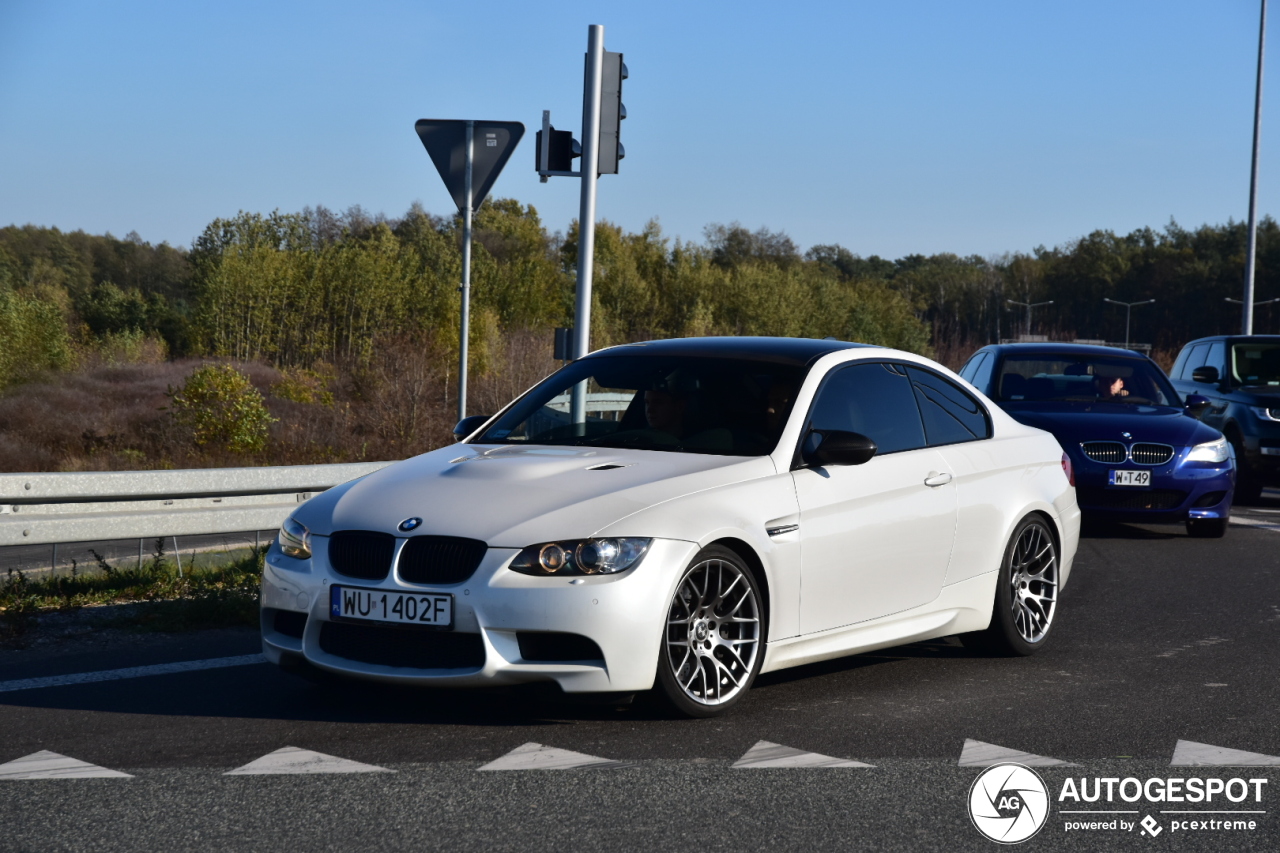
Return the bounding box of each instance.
[476,353,805,456]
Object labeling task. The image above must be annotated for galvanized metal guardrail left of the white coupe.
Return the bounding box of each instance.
[0,462,392,547]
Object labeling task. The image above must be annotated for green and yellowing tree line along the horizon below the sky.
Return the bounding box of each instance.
[0,199,1280,387]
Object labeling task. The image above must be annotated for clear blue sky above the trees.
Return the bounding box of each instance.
[0,0,1280,257]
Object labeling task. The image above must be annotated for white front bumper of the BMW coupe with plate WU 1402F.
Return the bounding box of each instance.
[261,537,698,693]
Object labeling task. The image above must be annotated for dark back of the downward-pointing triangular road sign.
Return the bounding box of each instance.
[413,119,525,213]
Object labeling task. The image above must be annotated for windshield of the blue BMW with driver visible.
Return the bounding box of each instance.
[996,352,1179,406]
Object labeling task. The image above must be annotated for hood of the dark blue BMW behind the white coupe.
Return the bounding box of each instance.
[1001,402,1221,448]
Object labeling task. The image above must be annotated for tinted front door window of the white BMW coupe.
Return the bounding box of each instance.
[809,362,924,455]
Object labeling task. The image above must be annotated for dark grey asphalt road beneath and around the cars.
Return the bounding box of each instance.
[0,501,1280,850]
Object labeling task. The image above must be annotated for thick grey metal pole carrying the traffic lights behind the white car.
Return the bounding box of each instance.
[570,24,604,425]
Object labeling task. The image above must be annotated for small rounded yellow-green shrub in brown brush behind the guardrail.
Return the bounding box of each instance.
[169,364,275,453]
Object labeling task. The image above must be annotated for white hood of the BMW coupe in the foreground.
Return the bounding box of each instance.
[294,444,774,548]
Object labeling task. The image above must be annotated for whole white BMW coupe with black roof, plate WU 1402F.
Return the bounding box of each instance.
[261,338,1080,716]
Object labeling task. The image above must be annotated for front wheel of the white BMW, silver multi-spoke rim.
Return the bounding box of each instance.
[655,546,767,717]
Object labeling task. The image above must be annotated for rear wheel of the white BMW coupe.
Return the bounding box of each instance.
[960,515,1060,657]
